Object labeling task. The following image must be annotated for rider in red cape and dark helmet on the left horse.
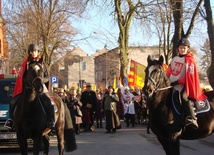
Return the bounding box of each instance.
[4,44,54,133]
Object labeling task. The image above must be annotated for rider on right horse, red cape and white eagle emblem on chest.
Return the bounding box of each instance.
[166,38,207,129]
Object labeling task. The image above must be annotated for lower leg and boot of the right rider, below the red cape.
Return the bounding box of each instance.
[183,100,198,129]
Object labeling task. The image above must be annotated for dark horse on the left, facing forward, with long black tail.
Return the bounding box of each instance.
[14,59,76,155]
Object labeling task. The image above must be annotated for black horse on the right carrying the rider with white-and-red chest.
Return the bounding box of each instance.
[143,56,214,155]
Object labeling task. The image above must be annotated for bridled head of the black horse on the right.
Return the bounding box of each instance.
[143,55,170,99]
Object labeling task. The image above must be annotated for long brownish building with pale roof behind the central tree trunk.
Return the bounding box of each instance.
[94,46,162,89]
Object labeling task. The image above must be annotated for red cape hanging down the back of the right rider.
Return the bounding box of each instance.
[185,52,207,101]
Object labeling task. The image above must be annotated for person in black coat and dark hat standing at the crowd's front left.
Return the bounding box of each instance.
[80,83,97,132]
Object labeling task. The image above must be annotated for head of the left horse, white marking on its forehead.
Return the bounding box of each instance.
[26,59,44,95]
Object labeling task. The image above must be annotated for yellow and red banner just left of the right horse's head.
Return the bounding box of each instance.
[128,60,146,88]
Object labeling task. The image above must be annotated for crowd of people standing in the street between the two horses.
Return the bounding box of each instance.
[55,83,148,134]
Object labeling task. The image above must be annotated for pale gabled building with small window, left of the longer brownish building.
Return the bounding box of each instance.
[50,48,95,89]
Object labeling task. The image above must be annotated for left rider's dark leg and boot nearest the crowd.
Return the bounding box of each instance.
[41,93,55,135]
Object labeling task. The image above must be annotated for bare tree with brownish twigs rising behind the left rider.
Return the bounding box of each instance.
[4,0,85,66]
